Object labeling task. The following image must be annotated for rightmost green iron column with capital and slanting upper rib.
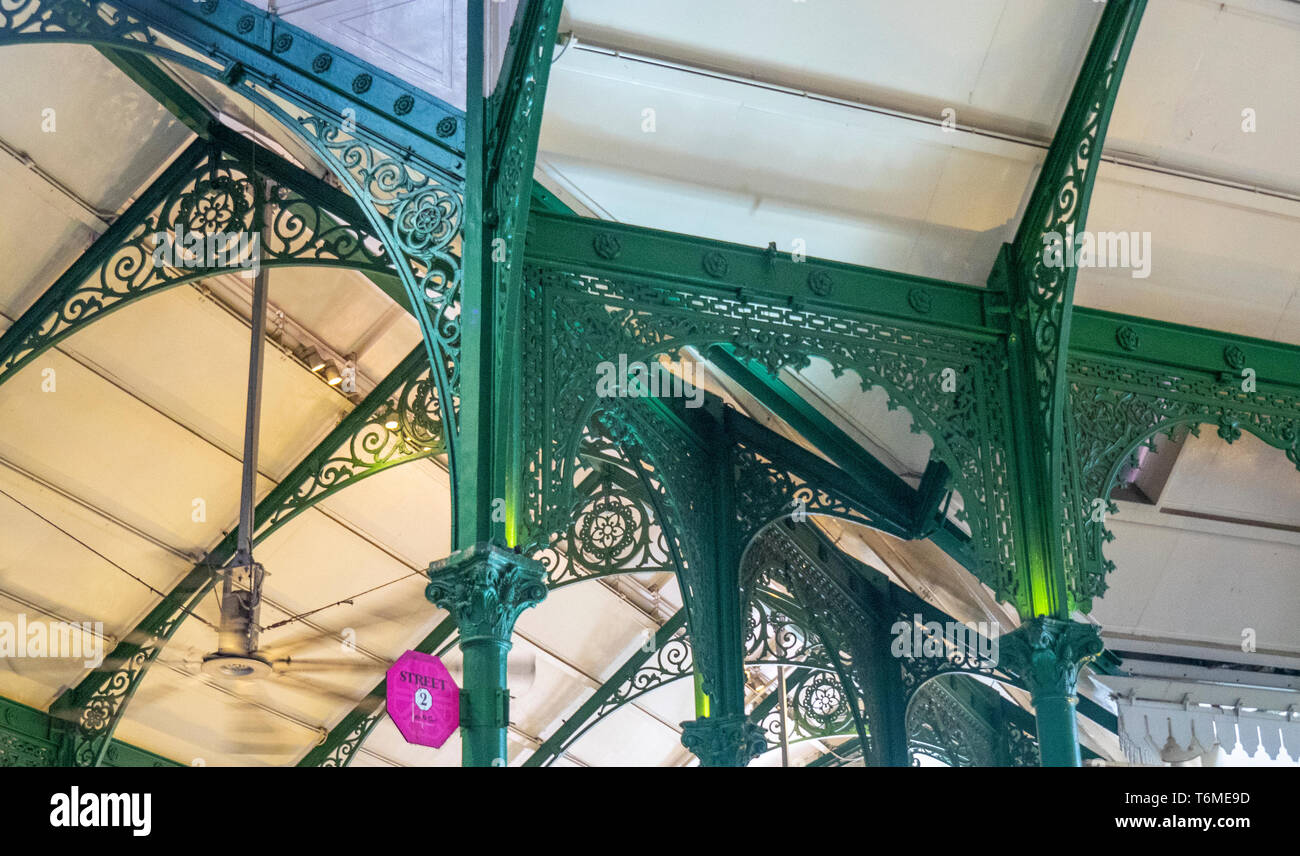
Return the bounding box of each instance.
[989,0,1145,766]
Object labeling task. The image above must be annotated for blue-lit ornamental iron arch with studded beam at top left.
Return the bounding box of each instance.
[0,0,464,507]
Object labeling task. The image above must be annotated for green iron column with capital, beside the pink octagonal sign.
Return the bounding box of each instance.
[444,0,562,766]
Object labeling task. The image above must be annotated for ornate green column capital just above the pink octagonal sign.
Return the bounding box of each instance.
[424,541,546,645]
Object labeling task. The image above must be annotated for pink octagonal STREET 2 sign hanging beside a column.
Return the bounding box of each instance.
[387,650,460,748]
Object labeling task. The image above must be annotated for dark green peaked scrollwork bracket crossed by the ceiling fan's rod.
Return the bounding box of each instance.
[0,126,397,382]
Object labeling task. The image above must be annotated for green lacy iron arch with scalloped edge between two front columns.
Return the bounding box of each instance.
[521,258,1018,598]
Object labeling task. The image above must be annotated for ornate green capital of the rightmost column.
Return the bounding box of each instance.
[1001,617,1105,705]
